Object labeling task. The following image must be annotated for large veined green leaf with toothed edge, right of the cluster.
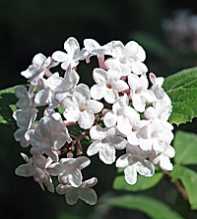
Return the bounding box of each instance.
[164,68,197,125]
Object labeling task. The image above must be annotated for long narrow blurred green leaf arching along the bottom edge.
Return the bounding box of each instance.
[106,195,183,219]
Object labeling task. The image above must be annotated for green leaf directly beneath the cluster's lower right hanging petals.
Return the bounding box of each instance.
[113,173,163,192]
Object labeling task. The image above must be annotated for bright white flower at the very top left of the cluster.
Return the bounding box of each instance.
[52,37,83,70]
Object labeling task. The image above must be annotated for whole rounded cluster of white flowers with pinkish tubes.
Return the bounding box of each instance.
[13,37,175,205]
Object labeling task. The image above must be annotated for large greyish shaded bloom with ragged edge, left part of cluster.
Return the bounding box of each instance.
[30,113,71,160]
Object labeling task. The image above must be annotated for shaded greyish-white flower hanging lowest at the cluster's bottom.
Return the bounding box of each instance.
[56,177,97,205]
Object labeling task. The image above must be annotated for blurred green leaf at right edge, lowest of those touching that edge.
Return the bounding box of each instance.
[171,165,197,209]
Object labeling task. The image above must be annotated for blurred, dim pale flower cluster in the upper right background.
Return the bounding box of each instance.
[163,10,197,52]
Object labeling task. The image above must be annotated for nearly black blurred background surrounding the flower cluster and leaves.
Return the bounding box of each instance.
[0,0,197,219]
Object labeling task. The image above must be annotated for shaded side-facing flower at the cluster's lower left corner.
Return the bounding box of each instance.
[15,154,54,192]
